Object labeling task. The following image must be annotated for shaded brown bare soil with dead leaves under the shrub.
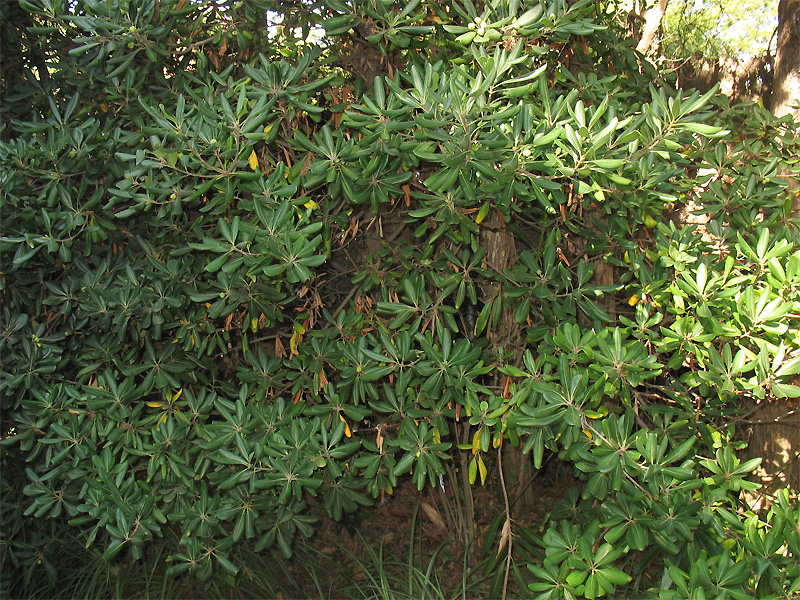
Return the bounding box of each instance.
[286,459,581,598]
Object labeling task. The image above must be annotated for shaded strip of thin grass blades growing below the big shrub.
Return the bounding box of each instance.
[0,504,544,600]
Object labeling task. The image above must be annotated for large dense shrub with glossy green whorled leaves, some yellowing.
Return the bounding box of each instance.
[0,0,800,599]
